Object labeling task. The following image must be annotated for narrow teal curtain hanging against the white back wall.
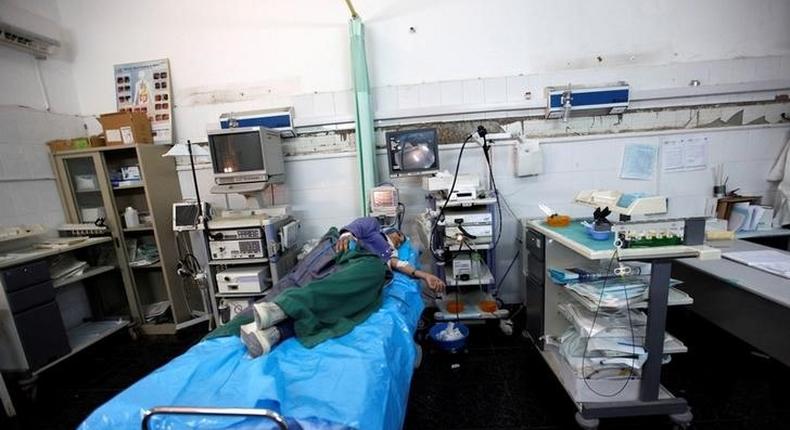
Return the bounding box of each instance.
[348,17,377,215]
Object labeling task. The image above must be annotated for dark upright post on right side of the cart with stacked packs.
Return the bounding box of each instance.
[639,260,672,401]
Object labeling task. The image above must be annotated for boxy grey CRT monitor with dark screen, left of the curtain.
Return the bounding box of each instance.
[208,127,285,185]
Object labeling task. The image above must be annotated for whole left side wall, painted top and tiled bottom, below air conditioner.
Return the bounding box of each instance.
[0,0,84,226]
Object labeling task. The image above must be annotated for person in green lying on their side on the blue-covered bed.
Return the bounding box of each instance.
[235,217,444,357]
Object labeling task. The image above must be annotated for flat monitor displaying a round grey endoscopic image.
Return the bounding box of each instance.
[386,128,439,177]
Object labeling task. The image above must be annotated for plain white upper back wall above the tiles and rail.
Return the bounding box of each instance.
[58,0,790,140]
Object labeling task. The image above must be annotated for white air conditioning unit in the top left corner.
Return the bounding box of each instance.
[0,2,60,60]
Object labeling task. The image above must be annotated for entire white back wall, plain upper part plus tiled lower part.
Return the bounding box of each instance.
[7,0,790,304]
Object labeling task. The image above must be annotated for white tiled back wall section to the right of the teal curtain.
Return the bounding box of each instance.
[390,125,790,302]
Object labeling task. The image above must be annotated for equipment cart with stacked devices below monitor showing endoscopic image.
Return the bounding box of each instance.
[426,192,509,321]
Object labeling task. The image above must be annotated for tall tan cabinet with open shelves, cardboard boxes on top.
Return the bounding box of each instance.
[51,144,208,334]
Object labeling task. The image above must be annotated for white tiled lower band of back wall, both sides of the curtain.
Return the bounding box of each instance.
[179,123,790,302]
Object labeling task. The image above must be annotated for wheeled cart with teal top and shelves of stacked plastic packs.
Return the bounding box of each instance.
[521,220,721,429]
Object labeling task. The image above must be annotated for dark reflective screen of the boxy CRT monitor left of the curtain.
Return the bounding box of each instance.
[208,131,264,174]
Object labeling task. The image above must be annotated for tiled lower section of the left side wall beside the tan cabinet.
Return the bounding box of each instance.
[0,106,83,227]
